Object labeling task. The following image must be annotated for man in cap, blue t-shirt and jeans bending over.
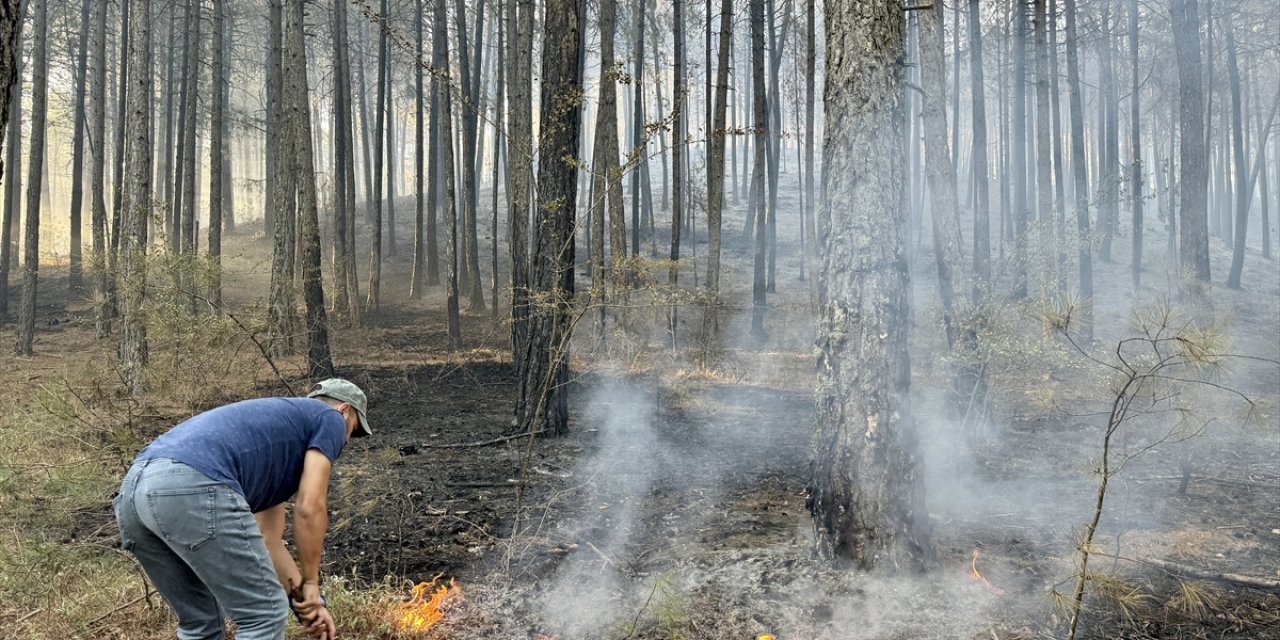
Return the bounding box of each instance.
[114,378,372,640]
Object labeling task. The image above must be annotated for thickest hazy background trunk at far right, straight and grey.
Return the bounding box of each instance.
[1170,0,1210,285]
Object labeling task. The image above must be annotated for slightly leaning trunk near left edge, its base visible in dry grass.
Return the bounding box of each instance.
[14,0,49,356]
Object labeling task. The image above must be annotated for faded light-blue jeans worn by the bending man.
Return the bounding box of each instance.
[114,458,289,640]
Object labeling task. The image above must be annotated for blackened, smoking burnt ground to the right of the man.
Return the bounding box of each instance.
[4,185,1280,640]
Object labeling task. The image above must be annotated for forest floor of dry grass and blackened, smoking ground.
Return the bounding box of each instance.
[0,186,1280,640]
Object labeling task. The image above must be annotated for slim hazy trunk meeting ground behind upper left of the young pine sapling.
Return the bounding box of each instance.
[1062,0,1093,342]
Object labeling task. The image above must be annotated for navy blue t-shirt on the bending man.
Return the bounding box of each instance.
[138,398,347,513]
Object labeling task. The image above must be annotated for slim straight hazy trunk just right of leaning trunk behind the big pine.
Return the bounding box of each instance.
[967,0,991,288]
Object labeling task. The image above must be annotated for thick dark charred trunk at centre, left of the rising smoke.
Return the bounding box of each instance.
[516,0,582,435]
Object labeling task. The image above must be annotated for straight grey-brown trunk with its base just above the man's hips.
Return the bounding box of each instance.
[118,0,152,394]
